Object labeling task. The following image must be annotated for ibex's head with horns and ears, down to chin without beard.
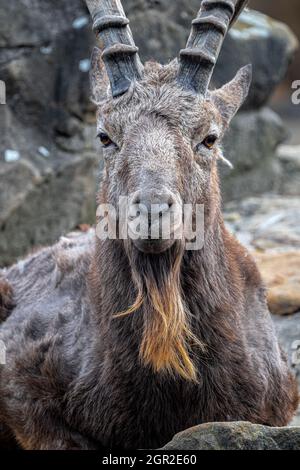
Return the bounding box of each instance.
[87,0,251,253]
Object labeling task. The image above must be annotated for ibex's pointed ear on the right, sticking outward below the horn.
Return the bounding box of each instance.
[211,65,252,129]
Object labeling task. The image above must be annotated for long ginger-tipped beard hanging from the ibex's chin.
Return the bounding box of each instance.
[117,242,204,382]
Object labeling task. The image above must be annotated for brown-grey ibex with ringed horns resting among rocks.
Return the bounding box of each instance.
[0,0,298,449]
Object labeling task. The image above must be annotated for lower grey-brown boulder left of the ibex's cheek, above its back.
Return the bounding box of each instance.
[0,151,97,266]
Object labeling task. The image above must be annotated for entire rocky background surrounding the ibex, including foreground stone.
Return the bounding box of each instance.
[0,0,300,448]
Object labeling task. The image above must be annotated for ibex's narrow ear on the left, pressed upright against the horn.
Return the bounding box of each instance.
[90,47,109,105]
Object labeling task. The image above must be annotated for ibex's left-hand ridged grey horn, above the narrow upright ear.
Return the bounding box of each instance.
[86,0,143,97]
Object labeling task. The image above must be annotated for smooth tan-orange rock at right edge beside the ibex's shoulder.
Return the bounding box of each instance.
[255,250,300,314]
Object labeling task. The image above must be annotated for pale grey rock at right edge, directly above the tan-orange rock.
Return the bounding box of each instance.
[224,195,300,253]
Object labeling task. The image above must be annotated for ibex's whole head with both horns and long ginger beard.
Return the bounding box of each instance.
[86,0,251,380]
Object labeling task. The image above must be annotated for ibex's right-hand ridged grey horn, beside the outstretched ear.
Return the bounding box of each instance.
[178,0,248,96]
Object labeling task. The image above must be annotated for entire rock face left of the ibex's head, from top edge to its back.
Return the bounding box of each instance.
[0,0,99,266]
